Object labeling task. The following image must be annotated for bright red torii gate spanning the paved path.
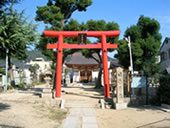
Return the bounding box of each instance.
[44,31,120,98]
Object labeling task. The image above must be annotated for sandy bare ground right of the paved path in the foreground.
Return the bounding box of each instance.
[96,107,170,128]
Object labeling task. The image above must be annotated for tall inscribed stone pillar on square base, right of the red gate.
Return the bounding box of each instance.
[115,67,127,109]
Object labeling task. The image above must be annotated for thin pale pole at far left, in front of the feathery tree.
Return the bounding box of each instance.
[4,49,9,92]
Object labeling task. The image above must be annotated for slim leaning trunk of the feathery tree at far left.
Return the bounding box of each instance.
[8,56,16,88]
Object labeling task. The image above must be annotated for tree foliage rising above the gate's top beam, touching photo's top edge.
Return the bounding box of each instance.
[36,0,92,30]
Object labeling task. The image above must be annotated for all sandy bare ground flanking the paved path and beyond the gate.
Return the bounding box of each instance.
[0,86,170,128]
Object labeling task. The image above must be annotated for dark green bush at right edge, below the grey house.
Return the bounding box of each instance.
[158,74,170,105]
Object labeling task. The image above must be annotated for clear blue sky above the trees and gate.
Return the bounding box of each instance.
[15,0,170,56]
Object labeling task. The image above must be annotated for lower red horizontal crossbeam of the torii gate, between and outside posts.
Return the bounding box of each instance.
[47,43,117,49]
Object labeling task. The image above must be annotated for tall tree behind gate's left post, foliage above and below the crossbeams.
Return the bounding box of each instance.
[35,0,92,62]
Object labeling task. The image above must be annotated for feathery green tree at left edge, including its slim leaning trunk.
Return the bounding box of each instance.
[0,4,37,86]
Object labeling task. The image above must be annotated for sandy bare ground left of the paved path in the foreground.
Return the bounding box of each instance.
[0,85,67,128]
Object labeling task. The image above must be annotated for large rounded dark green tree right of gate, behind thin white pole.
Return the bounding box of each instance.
[116,15,162,76]
